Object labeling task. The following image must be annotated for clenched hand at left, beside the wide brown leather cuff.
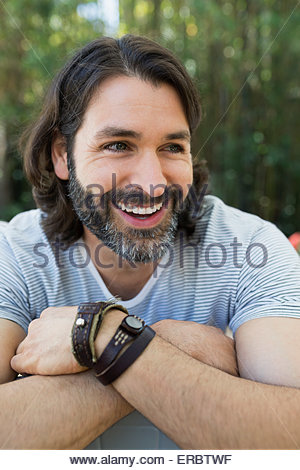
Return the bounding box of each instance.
[11,307,86,375]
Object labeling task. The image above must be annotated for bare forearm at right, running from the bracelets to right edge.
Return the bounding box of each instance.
[113,337,300,449]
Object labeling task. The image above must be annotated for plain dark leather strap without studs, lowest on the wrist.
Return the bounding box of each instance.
[96,326,156,385]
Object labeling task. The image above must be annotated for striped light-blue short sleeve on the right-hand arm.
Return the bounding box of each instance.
[229,222,300,334]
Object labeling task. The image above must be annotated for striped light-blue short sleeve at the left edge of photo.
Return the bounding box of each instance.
[0,231,32,332]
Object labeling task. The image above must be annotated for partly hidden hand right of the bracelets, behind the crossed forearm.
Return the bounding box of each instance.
[151,320,239,376]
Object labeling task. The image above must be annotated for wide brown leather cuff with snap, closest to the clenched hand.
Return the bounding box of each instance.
[72,301,128,368]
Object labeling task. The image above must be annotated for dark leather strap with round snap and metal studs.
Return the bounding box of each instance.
[94,315,146,375]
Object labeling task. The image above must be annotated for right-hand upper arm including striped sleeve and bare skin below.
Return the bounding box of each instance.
[230,222,300,388]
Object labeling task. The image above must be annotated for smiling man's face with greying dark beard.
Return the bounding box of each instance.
[64,76,192,263]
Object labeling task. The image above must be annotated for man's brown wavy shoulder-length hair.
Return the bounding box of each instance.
[21,34,208,245]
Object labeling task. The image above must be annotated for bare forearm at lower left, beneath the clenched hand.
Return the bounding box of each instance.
[0,372,132,449]
